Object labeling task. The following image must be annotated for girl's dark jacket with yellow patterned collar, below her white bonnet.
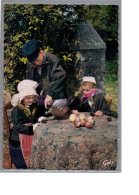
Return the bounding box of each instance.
[10,104,45,142]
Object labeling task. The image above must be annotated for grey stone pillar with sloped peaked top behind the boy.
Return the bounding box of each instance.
[71,21,106,94]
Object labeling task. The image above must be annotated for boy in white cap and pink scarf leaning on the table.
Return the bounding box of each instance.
[70,76,111,116]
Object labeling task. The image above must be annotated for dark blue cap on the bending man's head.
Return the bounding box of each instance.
[22,39,40,63]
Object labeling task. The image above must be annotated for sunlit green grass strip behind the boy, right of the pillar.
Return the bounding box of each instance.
[106,77,118,118]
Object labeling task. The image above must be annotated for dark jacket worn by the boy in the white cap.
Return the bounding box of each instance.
[70,93,111,115]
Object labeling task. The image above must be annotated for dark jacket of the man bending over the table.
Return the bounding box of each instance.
[28,53,67,100]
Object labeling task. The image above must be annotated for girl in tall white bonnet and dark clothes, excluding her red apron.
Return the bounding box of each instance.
[10,80,46,168]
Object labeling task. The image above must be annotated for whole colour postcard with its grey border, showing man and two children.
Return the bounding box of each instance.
[0,0,121,172]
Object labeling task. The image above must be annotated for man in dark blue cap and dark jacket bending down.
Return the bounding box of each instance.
[22,39,67,107]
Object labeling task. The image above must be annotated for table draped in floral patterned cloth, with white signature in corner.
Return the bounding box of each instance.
[30,116,117,170]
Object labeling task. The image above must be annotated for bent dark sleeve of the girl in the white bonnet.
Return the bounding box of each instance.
[11,107,34,135]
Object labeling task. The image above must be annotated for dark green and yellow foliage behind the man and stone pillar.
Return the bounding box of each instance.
[4,4,118,114]
